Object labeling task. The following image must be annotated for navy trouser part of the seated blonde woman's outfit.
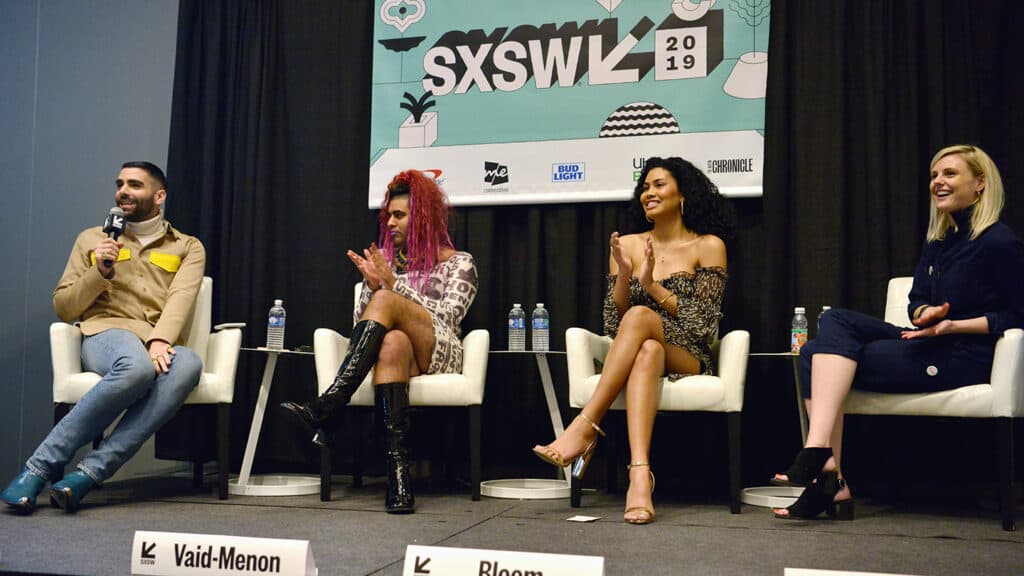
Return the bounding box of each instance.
[800,308,995,398]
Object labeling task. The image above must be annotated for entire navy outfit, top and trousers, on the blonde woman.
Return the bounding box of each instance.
[800,208,1024,398]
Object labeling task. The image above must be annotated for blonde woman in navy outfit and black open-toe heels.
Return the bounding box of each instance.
[771,146,1024,520]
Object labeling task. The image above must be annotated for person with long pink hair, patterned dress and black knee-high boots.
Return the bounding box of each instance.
[282,170,477,513]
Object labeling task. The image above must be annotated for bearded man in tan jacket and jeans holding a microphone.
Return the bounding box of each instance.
[0,162,206,512]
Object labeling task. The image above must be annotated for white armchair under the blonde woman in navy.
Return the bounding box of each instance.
[846,277,1024,531]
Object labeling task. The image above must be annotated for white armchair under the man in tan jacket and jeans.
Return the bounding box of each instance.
[50,277,242,500]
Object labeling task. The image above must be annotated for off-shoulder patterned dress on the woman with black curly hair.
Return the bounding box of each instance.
[604,266,729,379]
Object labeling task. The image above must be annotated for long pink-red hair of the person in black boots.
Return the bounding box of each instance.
[377,170,455,292]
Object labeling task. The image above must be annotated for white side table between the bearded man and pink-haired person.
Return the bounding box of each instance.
[227,346,319,496]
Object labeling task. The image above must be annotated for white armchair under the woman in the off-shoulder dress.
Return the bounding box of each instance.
[565,328,751,513]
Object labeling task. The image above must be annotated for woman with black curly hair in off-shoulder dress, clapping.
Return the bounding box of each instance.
[534,158,733,524]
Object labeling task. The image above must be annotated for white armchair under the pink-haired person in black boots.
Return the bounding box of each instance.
[313,283,490,502]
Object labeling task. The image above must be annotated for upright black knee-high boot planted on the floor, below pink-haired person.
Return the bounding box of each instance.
[374,382,416,513]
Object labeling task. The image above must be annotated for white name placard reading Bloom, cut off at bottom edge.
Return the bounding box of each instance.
[401,545,604,576]
